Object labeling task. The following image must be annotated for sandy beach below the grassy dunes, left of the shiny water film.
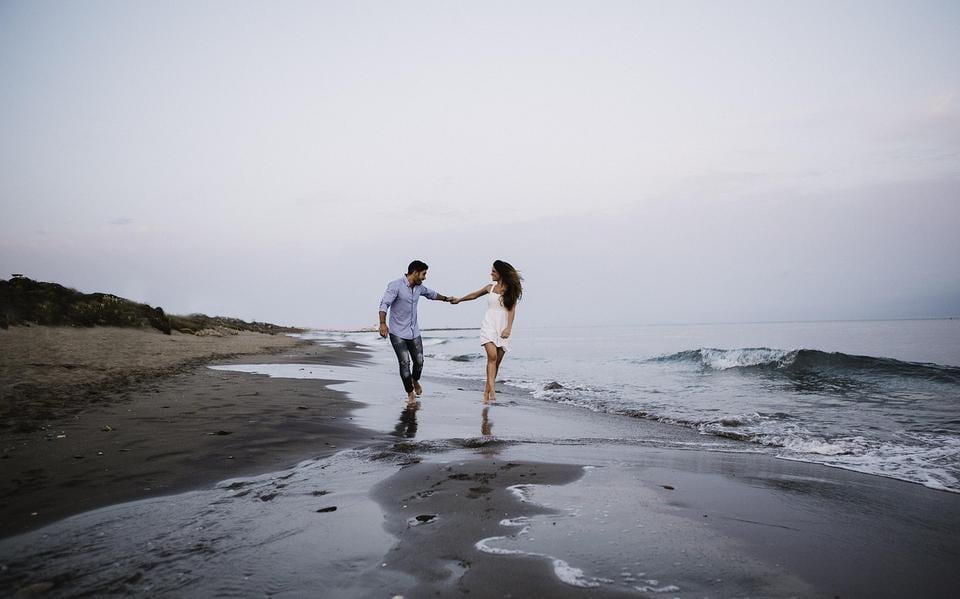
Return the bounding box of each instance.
[0,327,366,536]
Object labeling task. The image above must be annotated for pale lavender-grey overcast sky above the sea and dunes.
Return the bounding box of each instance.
[0,0,960,330]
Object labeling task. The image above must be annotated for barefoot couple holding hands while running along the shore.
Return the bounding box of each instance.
[380,260,523,403]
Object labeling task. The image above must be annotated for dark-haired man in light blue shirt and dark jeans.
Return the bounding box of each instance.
[380,260,450,403]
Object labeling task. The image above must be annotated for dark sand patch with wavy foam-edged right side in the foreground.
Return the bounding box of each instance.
[372,459,636,597]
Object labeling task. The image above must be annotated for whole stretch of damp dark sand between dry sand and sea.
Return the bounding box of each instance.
[0,331,960,597]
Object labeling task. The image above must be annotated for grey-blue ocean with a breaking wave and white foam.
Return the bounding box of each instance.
[316,319,960,493]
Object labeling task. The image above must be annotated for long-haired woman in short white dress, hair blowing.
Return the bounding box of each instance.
[450,260,523,403]
